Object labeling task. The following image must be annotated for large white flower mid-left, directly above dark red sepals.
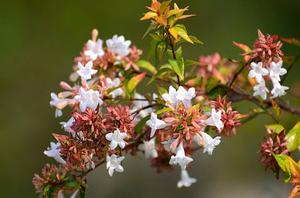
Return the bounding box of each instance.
[75,87,103,112]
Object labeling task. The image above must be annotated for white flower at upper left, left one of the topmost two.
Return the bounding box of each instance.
[84,39,104,61]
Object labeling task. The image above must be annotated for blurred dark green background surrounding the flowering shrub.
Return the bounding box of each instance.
[0,0,300,198]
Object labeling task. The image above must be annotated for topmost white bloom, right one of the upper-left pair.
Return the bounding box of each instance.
[106,35,131,56]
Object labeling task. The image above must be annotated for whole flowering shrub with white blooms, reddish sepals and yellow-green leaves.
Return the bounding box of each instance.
[33,0,300,197]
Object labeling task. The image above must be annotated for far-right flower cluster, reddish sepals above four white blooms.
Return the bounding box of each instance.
[240,30,289,100]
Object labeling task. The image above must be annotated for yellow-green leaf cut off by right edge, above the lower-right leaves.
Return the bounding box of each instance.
[286,122,300,152]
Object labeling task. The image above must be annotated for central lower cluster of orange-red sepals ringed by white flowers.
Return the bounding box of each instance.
[142,86,241,187]
